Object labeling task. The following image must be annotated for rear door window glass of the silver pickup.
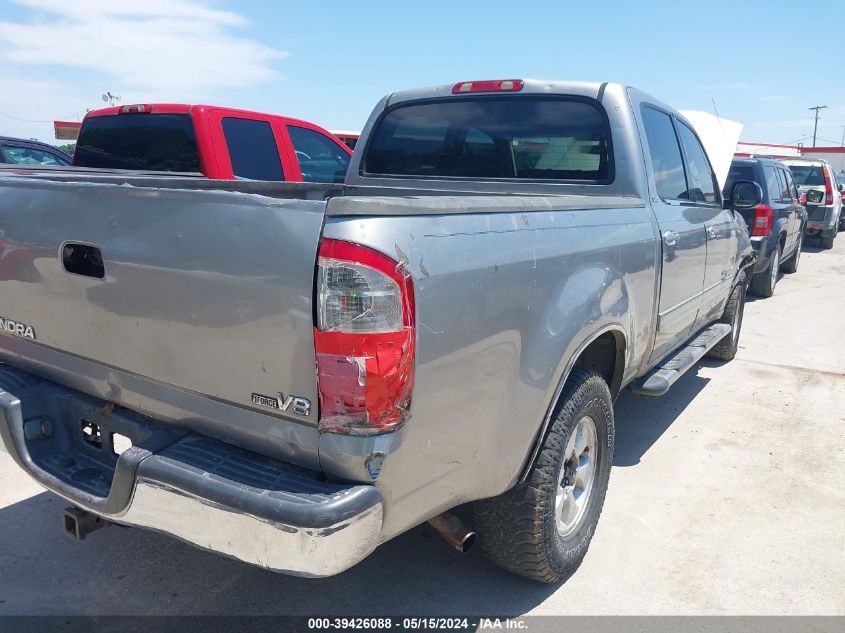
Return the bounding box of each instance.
[642,108,687,200]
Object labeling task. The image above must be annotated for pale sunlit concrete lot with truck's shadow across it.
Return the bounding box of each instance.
[0,234,845,615]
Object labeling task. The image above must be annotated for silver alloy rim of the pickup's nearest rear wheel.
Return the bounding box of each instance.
[555,415,598,536]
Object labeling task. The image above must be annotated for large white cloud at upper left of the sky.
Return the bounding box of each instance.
[0,0,286,96]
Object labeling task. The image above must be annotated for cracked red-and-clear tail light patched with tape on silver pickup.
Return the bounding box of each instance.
[314,239,416,435]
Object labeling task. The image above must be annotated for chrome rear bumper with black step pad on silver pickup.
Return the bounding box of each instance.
[0,366,383,576]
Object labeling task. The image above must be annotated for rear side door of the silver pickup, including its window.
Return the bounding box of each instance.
[641,105,712,364]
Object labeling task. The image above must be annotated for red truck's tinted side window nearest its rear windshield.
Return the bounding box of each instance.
[223,117,285,181]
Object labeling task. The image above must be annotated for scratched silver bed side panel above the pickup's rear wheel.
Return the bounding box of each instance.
[321,206,658,535]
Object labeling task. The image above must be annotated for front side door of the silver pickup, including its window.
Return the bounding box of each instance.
[675,119,739,329]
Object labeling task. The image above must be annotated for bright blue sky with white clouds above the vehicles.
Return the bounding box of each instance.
[0,0,845,145]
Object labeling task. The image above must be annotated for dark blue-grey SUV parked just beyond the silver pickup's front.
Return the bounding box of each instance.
[723,158,807,297]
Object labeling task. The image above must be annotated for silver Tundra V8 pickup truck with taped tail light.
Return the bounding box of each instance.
[0,80,755,582]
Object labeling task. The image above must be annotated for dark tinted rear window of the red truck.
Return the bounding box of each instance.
[73,113,200,172]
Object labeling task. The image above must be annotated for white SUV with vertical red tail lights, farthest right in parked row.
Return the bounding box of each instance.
[783,158,845,249]
